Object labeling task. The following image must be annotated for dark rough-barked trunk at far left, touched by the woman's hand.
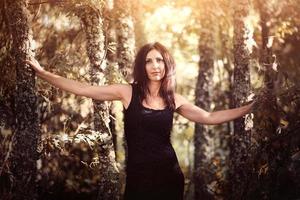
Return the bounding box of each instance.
[5,0,40,200]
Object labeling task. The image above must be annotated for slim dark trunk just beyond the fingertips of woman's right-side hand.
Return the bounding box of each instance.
[254,0,280,199]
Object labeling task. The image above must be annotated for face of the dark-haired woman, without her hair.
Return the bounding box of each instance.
[146,49,165,81]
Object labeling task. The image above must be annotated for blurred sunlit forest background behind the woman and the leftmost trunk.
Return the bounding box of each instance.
[0,0,300,200]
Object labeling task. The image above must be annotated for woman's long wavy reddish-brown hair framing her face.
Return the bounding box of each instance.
[133,42,176,110]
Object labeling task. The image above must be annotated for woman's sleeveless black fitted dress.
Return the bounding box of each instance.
[124,84,184,200]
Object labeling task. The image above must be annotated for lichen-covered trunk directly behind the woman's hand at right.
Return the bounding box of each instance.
[228,0,251,199]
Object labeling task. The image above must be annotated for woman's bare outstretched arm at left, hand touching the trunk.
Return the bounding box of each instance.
[25,59,131,105]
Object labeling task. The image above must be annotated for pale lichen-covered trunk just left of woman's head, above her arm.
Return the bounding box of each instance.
[115,0,135,81]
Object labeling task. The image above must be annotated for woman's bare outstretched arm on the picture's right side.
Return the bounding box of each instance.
[175,94,253,125]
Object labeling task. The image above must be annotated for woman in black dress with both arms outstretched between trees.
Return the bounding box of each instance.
[26,42,252,200]
